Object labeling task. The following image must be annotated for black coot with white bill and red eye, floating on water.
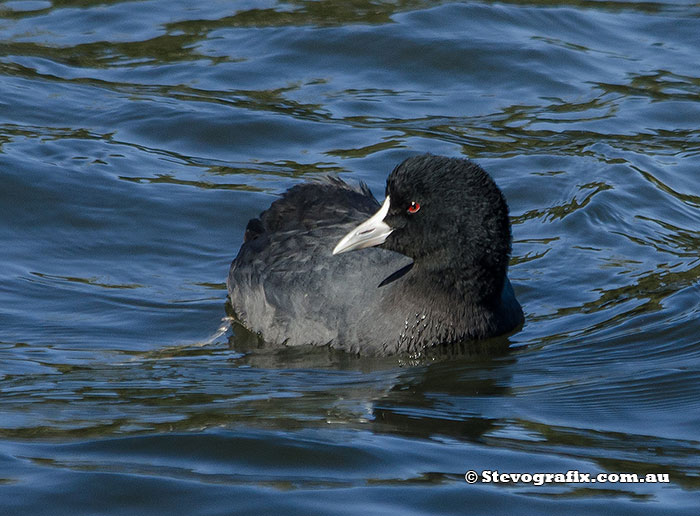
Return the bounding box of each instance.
[227,154,523,355]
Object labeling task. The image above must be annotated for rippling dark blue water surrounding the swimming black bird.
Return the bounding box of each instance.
[0,0,700,516]
